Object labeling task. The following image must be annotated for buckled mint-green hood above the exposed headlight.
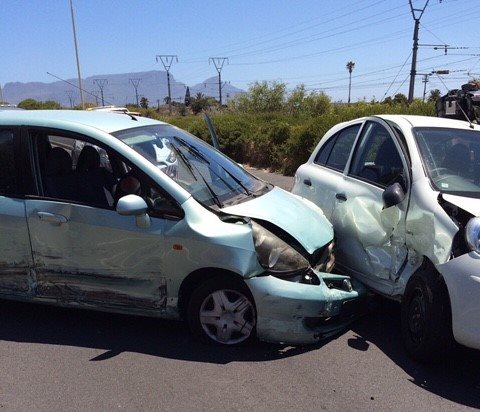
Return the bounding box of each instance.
[222,187,333,254]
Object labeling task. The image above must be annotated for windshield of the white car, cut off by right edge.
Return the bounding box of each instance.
[414,127,480,198]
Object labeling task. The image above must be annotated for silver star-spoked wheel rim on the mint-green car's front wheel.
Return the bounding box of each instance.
[200,290,255,345]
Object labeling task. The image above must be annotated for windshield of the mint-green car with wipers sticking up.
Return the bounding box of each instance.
[112,124,271,208]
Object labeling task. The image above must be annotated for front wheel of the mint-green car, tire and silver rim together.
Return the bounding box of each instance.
[187,276,256,345]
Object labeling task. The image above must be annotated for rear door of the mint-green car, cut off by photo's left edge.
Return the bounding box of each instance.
[0,127,34,296]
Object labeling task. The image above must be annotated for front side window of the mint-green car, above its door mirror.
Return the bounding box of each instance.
[32,132,178,217]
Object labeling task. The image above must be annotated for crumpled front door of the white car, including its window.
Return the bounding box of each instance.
[332,119,409,294]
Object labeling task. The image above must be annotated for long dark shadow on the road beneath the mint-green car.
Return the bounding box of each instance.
[0,300,319,364]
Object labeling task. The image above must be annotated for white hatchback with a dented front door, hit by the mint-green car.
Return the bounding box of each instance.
[292,115,480,359]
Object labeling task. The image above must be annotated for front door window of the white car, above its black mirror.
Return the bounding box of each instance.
[350,122,405,187]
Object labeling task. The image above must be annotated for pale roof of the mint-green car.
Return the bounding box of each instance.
[0,110,166,133]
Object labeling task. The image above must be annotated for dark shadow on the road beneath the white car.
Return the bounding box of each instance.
[348,299,480,409]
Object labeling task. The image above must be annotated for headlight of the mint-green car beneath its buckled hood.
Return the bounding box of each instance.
[252,221,310,275]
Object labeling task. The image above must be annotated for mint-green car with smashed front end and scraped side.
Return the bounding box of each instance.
[0,111,362,345]
